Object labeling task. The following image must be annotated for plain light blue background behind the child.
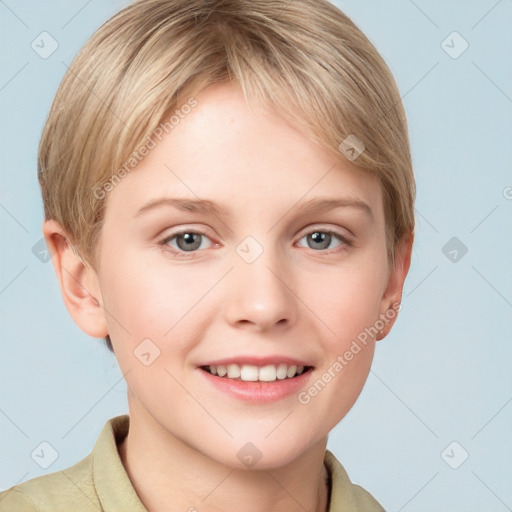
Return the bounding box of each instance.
[0,0,512,512]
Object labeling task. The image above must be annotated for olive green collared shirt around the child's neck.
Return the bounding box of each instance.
[0,414,384,512]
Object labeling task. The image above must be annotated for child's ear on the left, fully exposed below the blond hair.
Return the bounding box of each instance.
[43,220,108,338]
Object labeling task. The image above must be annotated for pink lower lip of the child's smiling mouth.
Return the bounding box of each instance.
[198,368,313,404]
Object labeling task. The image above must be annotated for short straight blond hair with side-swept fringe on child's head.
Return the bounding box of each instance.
[38,0,415,350]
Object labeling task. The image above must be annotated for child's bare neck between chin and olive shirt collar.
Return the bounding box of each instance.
[118,404,329,512]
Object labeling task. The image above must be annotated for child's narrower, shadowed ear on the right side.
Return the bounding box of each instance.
[377,233,414,340]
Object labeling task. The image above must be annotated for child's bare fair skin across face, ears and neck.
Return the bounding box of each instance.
[43,84,412,512]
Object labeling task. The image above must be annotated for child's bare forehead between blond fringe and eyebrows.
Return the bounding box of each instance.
[107,83,381,221]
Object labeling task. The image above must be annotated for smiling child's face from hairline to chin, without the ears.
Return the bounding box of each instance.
[91,84,404,467]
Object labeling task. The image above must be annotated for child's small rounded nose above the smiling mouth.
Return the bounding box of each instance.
[225,247,298,332]
